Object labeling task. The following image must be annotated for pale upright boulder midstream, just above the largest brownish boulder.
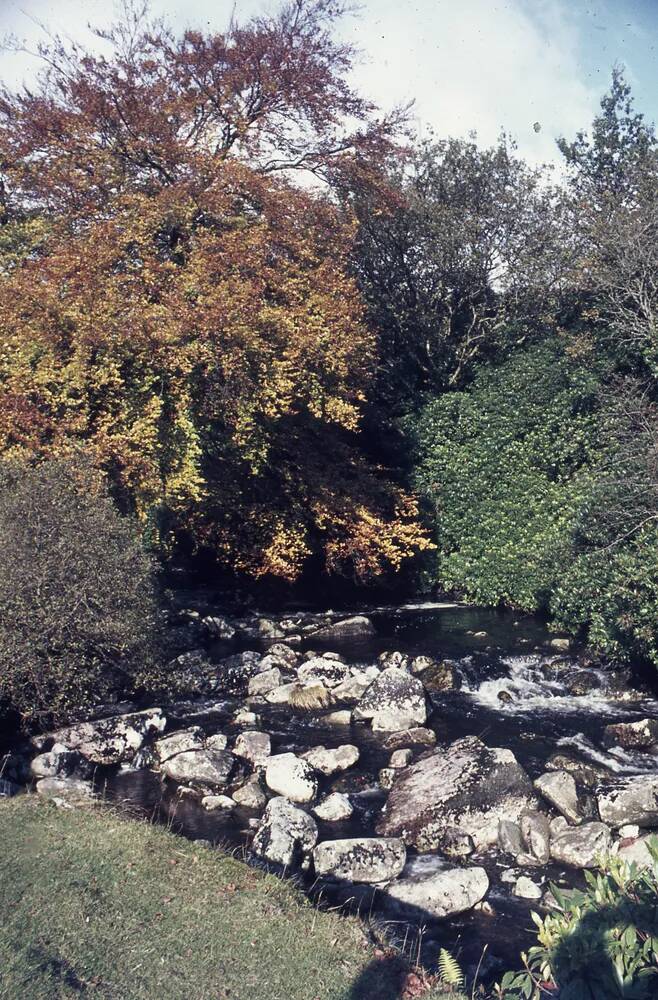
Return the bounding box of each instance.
[353,667,427,732]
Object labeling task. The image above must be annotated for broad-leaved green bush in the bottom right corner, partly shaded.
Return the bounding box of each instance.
[496,838,658,1000]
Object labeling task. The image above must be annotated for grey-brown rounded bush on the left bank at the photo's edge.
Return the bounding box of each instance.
[0,455,163,724]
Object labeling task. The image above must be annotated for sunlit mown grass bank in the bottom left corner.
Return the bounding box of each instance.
[0,796,462,1000]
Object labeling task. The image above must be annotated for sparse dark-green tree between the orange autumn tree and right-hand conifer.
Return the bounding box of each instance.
[341,136,570,409]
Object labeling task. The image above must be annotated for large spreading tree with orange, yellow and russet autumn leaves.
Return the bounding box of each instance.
[0,0,427,579]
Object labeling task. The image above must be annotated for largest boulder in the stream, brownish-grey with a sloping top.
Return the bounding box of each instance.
[377,736,536,851]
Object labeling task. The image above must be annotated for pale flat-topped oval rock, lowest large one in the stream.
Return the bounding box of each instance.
[384,868,489,919]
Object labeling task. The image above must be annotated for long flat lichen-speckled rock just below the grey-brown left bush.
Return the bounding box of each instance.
[45,708,167,764]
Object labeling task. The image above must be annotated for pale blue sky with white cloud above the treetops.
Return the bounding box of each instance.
[0,0,658,163]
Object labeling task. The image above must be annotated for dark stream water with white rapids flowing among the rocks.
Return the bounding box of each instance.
[103,603,658,979]
